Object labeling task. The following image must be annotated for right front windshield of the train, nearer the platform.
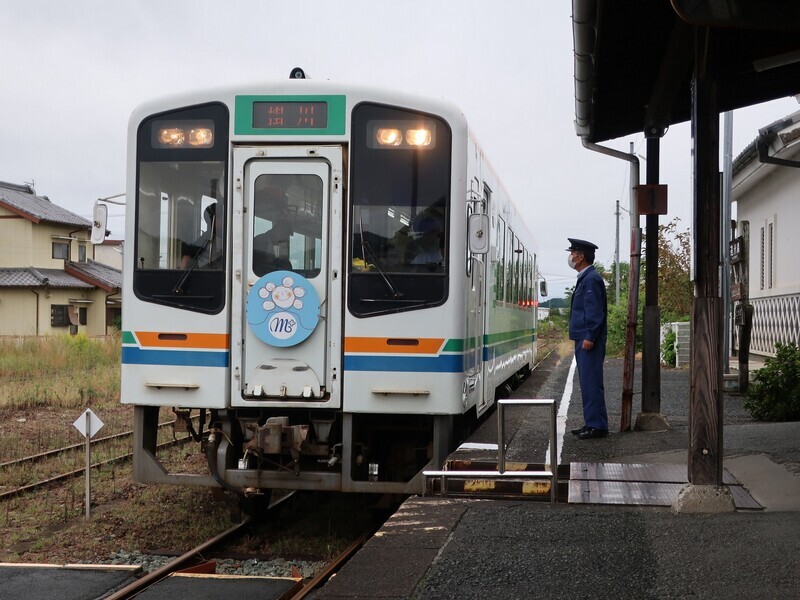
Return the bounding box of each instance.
[348,104,451,317]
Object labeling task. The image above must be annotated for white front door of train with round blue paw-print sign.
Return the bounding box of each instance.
[232,146,342,408]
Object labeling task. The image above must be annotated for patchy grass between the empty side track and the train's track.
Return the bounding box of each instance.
[0,440,238,563]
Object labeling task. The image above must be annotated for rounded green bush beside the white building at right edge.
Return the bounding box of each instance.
[744,343,800,421]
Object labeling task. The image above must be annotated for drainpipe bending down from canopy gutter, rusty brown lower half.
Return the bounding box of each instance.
[581,137,642,431]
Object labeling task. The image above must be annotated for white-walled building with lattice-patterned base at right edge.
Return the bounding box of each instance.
[731,111,800,356]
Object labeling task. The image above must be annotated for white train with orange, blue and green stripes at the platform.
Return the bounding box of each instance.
[106,72,539,495]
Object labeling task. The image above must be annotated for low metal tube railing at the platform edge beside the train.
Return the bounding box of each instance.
[422,398,558,504]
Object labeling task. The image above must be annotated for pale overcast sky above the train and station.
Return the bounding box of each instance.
[0,0,800,297]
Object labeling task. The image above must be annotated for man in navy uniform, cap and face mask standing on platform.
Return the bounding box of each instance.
[567,238,608,440]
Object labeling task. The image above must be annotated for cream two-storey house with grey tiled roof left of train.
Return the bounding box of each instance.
[0,181,122,336]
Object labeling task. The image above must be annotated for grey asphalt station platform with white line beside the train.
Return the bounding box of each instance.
[312,354,800,600]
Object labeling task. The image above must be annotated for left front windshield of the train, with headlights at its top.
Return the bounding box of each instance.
[134,105,228,313]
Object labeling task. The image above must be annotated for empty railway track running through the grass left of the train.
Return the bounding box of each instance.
[0,421,197,500]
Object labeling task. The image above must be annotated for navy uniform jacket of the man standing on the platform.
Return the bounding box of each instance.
[569,265,608,345]
